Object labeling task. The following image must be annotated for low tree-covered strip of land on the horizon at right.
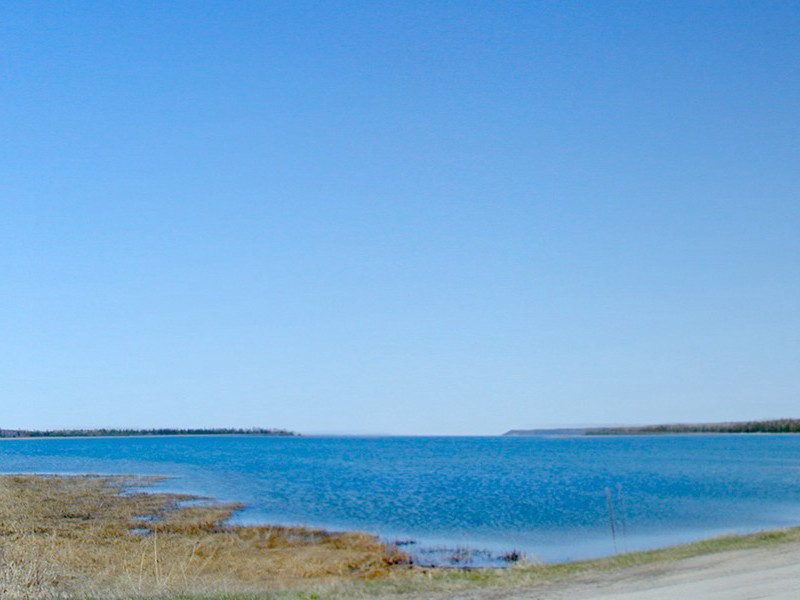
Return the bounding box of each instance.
[503,419,800,436]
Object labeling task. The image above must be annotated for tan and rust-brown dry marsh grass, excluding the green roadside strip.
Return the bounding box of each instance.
[0,475,402,598]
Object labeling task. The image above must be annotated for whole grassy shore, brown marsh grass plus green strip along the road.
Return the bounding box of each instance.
[0,475,800,599]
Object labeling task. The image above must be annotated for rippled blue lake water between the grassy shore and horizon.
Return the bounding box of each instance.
[0,435,800,561]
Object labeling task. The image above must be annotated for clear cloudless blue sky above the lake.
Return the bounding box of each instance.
[0,0,800,434]
